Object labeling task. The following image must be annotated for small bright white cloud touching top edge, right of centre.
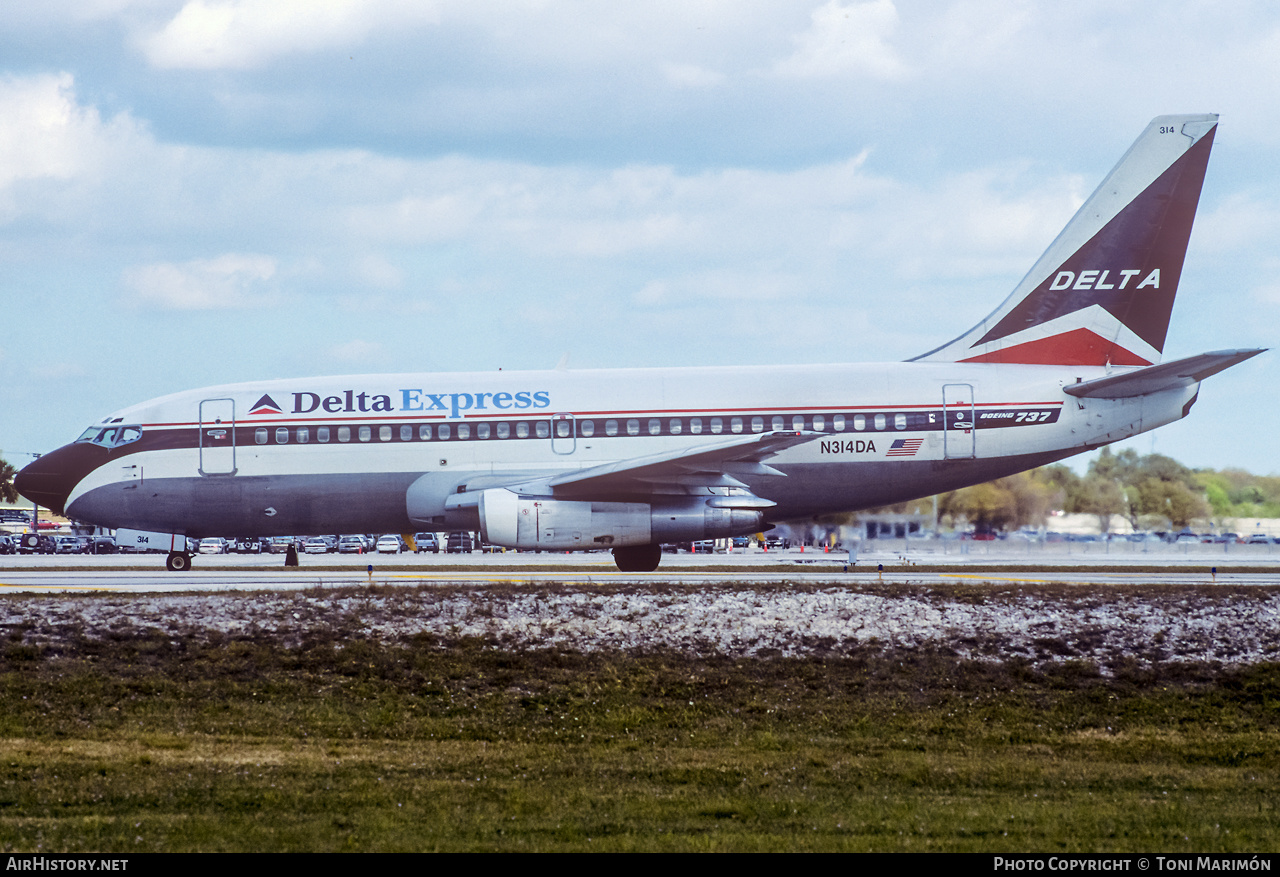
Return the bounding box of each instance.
[773,0,908,79]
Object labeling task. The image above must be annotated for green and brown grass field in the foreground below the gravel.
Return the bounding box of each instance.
[0,581,1280,853]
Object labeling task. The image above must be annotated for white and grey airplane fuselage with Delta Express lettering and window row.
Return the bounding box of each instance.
[47,362,1198,536]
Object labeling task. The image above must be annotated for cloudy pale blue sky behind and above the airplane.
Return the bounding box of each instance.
[0,0,1280,472]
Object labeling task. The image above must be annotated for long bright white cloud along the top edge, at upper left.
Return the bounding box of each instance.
[141,0,439,69]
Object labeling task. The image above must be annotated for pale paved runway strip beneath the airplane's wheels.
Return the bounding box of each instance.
[0,552,1280,594]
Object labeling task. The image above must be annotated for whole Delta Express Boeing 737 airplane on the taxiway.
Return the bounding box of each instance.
[15,115,1262,571]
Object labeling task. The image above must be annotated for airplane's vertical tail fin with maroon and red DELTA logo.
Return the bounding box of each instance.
[914,115,1217,365]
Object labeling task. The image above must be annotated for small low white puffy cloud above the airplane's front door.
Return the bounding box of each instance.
[123,253,276,311]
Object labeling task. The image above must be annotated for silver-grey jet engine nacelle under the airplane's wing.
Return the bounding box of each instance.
[479,488,757,551]
